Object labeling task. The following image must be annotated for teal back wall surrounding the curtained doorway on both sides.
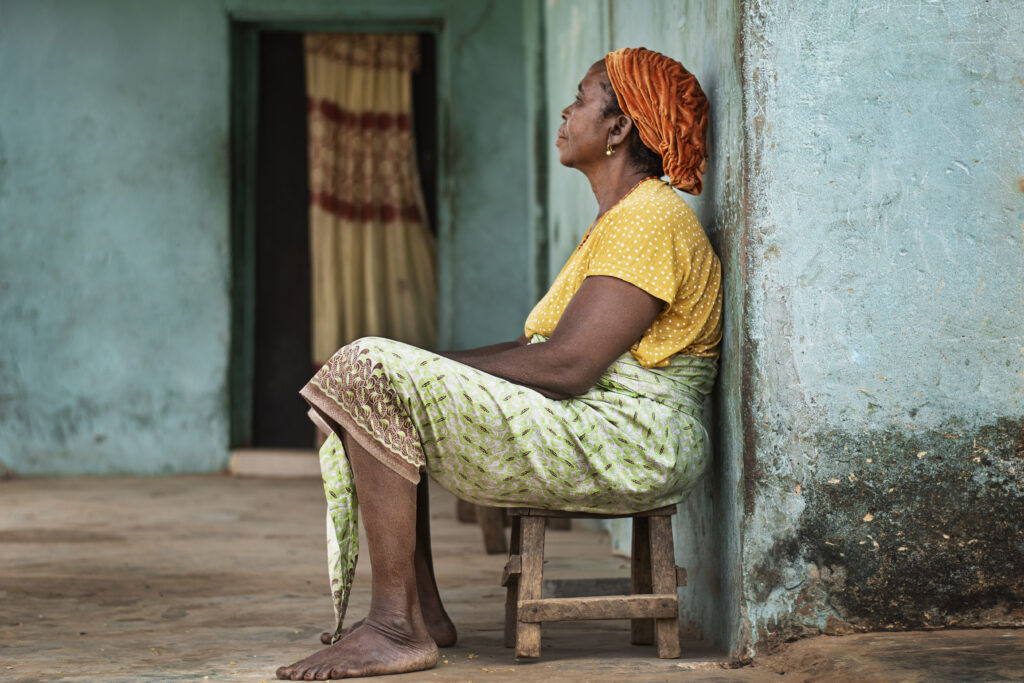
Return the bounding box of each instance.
[0,0,536,474]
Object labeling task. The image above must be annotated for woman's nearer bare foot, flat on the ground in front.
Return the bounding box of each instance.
[278,618,437,681]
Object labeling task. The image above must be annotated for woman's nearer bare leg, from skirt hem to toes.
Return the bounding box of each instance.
[278,434,437,681]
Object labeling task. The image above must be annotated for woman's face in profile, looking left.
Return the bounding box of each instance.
[555,61,614,170]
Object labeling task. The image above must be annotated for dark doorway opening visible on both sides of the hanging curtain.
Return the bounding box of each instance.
[251,31,437,449]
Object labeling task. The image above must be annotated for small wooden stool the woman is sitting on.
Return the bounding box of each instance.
[502,505,686,658]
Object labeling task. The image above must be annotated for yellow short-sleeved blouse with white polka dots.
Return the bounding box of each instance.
[525,178,722,368]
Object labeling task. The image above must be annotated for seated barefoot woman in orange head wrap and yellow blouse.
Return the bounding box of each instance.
[278,48,722,680]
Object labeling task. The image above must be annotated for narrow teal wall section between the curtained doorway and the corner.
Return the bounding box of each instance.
[432,0,539,348]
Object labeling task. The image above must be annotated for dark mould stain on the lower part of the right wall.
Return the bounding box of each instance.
[748,420,1024,647]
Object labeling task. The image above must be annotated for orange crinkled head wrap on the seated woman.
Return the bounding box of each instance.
[604,47,708,195]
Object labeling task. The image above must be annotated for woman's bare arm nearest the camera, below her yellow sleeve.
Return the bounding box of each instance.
[449,275,666,398]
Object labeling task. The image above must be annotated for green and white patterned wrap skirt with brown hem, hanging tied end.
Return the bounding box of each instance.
[300,337,718,643]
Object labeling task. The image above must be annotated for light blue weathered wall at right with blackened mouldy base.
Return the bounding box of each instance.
[742,0,1024,649]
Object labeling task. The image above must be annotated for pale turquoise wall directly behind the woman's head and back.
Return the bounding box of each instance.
[545,0,743,649]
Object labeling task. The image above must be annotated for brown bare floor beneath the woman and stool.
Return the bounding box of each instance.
[0,476,1024,682]
